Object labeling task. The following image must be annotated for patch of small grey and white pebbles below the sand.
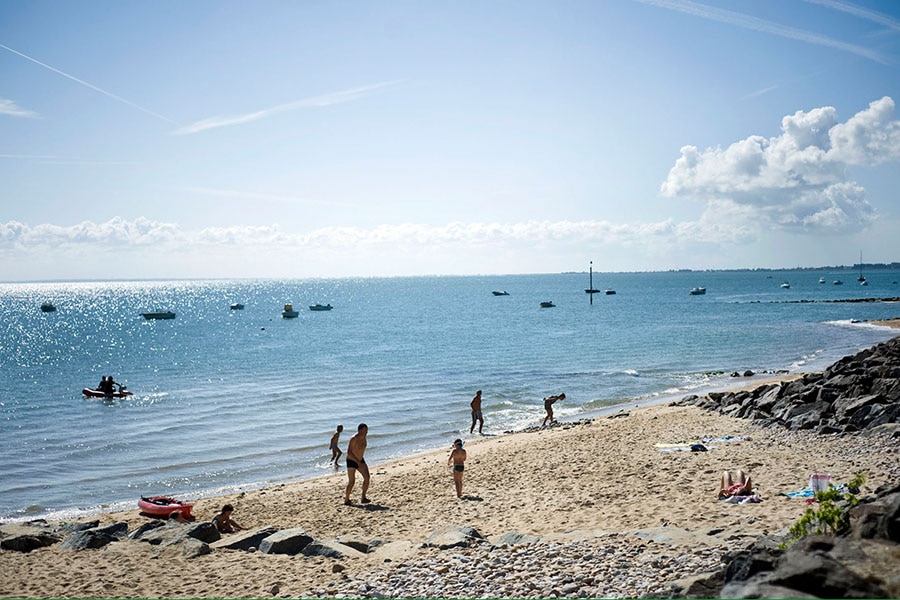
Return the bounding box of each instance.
[302,536,734,598]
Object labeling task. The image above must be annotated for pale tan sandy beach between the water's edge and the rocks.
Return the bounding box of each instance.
[0,382,900,597]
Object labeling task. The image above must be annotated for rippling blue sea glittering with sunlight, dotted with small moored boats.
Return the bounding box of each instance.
[0,270,900,522]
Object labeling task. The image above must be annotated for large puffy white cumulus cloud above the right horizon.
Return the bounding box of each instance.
[661,97,900,232]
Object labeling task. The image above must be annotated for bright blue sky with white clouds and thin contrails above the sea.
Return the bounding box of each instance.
[0,0,900,281]
